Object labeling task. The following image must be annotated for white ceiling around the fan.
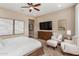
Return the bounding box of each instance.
[0,3,75,17]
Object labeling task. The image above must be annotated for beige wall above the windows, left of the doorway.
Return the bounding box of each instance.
[0,8,32,36]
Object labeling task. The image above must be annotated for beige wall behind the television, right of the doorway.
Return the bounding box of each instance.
[34,7,75,37]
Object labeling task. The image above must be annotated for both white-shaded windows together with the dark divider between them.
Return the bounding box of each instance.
[0,18,24,35]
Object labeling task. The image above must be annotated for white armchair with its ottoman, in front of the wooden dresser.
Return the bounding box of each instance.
[47,33,62,47]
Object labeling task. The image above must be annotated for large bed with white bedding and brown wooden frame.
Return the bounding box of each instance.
[0,36,44,56]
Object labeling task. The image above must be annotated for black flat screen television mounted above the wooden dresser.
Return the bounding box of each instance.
[39,21,52,30]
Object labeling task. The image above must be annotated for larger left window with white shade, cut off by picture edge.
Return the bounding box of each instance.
[0,18,13,35]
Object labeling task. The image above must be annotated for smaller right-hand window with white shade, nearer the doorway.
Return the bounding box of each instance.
[15,20,24,34]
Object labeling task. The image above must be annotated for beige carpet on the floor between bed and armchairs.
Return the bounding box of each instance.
[39,39,71,56]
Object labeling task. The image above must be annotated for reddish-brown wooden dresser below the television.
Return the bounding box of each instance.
[38,31,52,40]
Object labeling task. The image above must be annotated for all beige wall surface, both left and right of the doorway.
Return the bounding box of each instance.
[0,7,75,37]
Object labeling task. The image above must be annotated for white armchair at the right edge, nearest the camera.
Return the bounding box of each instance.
[61,36,79,55]
